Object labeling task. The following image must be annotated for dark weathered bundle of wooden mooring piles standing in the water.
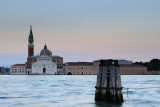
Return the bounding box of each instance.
[95,59,123,103]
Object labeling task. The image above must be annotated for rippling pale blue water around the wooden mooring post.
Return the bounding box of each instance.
[0,75,160,107]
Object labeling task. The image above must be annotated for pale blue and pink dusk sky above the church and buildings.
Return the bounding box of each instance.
[0,0,160,66]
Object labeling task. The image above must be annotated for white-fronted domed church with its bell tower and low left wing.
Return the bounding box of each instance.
[10,26,63,75]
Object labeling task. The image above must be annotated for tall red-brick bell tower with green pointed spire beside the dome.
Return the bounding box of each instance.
[28,26,34,57]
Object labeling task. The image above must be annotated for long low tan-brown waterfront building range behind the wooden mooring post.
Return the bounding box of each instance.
[64,60,151,75]
